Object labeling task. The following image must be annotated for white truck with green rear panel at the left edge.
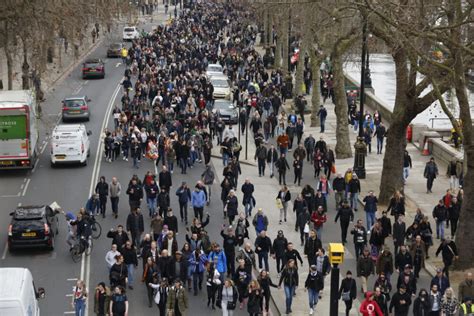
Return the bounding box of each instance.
[0,90,39,169]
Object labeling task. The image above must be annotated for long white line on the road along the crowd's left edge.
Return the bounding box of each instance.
[81,84,120,316]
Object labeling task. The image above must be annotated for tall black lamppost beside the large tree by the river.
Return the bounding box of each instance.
[353,18,371,179]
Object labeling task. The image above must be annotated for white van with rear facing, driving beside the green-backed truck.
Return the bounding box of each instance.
[51,124,91,167]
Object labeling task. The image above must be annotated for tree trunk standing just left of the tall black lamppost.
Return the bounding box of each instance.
[334,54,352,159]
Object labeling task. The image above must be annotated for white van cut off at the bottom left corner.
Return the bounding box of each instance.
[0,268,44,316]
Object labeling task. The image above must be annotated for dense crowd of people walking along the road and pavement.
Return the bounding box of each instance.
[63,3,474,316]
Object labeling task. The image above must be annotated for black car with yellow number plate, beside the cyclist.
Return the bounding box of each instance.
[8,205,59,251]
